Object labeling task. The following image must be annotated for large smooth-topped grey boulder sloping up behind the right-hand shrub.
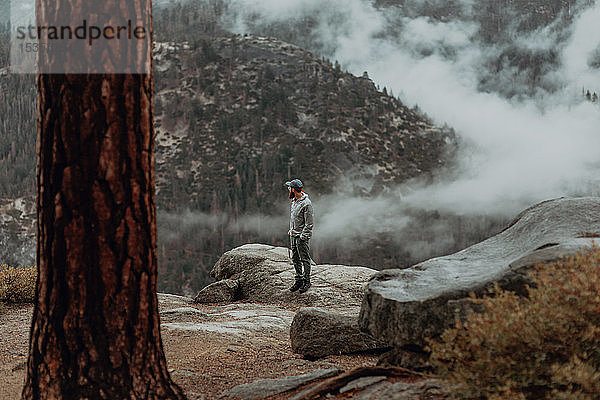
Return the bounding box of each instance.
[360,197,600,347]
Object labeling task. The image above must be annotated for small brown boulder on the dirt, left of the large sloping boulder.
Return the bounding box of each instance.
[290,307,388,359]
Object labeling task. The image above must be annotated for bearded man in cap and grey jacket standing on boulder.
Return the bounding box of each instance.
[285,179,313,293]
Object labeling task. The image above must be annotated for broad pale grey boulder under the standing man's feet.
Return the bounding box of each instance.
[198,244,377,307]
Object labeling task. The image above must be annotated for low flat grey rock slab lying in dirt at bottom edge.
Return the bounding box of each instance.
[221,368,342,400]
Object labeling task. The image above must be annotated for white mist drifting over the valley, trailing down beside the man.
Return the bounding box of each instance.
[199,0,600,260]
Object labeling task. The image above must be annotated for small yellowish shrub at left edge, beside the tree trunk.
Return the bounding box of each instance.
[0,264,37,303]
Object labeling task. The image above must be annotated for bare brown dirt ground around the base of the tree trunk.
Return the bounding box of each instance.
[0,305,377,400]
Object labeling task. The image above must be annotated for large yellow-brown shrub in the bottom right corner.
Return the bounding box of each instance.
[429,246,600,400]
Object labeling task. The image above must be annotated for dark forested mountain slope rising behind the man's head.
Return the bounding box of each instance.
[155,36,454,212]
